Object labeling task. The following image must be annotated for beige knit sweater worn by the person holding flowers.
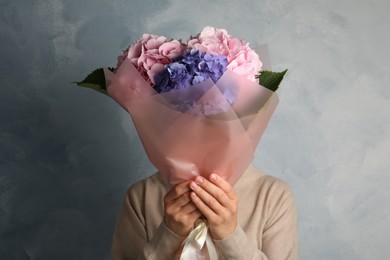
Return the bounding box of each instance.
[112,166,299,260]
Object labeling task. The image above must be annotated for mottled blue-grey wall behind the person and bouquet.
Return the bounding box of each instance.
[0,0,390,260]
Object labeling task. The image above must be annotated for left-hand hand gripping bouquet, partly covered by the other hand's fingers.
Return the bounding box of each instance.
[164,181,201,237]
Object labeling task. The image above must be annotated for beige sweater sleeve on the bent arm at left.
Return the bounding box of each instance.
[111,187,183,260]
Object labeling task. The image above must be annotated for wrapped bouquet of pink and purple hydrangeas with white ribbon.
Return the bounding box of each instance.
[77,27,287,259]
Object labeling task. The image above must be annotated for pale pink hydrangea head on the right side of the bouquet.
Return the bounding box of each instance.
[187,26,263,81]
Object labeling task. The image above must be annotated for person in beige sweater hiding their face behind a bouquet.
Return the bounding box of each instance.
[112,166,299,260]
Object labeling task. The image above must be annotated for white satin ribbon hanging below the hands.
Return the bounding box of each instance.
[180,220,218,260]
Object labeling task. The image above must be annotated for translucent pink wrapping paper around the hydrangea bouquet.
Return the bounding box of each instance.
[106,59,278,185]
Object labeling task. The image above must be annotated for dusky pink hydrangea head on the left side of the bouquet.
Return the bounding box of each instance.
[116,34,186,85]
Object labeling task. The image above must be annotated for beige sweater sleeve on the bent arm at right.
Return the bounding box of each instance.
[215,183,299,260]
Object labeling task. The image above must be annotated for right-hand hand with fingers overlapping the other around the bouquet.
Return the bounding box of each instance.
[190,173,238,240]
